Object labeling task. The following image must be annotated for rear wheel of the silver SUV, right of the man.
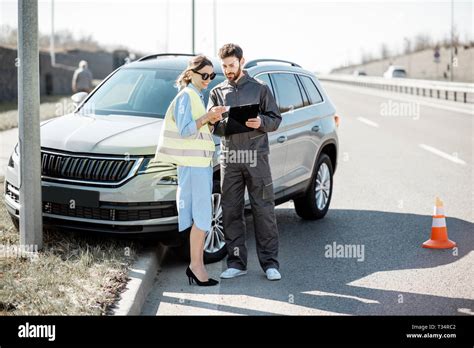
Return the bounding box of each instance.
[294,153,333,220]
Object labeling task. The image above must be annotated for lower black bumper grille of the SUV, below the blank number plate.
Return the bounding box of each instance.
[43,201,178,221]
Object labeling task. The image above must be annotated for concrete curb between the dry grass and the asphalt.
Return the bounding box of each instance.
[112,244,168,315]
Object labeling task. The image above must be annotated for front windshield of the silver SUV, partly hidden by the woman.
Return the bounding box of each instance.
[78,68,224,118]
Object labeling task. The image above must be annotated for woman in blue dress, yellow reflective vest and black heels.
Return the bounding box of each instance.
[155,55,225,286]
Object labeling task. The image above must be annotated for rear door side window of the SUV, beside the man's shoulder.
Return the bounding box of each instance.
[272,73,303,113]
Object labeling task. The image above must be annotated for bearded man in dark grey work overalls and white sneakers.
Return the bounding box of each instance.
[208,44,281,280]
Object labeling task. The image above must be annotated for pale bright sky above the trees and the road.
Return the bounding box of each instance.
[0,0,474,72]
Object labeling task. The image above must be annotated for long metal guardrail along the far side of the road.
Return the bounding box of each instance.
[317,74,474,103]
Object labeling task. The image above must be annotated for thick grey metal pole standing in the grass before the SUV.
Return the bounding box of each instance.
[18,0,43,249]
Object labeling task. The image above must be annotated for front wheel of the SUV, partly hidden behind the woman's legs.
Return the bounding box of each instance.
[179,179,227,264]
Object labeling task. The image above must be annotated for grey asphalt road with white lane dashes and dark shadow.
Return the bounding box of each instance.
[142,83,474,315]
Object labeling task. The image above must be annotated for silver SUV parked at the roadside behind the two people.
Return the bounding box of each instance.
[5,54,339,262]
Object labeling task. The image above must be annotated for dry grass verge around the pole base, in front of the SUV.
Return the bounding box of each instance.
[0,177,145,315]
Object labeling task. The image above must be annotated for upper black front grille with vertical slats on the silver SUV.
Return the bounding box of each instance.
[41,151,137,183]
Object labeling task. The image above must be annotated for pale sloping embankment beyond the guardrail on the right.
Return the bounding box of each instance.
[332,47,474,83]
